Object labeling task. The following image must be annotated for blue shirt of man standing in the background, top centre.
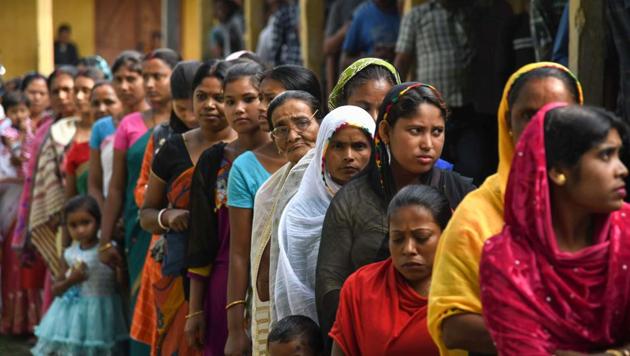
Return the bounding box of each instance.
[343,1,400,55]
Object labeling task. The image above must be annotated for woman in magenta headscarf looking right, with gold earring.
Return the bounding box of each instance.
[480,103,630,355]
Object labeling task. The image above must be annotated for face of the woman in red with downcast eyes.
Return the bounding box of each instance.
[389,205,442,296]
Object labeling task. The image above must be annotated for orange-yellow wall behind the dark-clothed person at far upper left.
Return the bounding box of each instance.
[52,0,95,57]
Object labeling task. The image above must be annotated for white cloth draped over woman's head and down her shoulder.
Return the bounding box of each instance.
[273,105,376,322]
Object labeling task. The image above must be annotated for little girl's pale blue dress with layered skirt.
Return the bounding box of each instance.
[31,244,129,356]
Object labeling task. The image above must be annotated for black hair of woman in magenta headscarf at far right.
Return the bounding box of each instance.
[545,105,628,173]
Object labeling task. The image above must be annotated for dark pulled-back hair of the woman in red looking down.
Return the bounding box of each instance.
[387,184,452,230]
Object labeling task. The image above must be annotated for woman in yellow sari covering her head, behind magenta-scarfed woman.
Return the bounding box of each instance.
[428,62,583,355]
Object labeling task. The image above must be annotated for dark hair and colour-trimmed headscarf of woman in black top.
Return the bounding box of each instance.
[366,82,448,204]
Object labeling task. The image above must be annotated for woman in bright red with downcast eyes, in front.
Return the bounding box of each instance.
[330,185,451,356]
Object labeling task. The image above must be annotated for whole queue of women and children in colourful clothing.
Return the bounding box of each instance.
[1,49,630,355]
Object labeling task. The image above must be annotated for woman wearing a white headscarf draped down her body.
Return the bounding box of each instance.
[273,106,375,321]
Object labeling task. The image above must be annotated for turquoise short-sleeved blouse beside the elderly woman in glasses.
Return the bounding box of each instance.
[227,151,271,209]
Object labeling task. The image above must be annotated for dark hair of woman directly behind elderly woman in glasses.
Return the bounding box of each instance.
[259,64,322,107]
